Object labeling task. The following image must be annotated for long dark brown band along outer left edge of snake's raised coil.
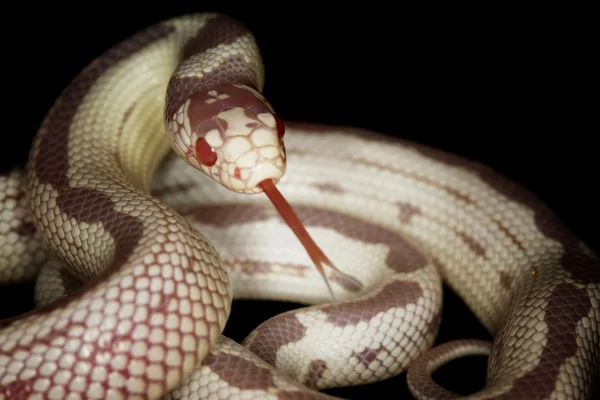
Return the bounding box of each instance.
[18,24,173,296]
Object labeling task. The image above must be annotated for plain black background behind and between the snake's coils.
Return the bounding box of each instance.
[0,2,600,399]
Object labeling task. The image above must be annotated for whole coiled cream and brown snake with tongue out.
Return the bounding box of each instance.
[0,13,600,400]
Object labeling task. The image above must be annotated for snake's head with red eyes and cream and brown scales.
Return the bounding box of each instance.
[167,84,286,194]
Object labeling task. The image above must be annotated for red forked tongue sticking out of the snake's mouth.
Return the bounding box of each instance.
[259,179,341,299]
